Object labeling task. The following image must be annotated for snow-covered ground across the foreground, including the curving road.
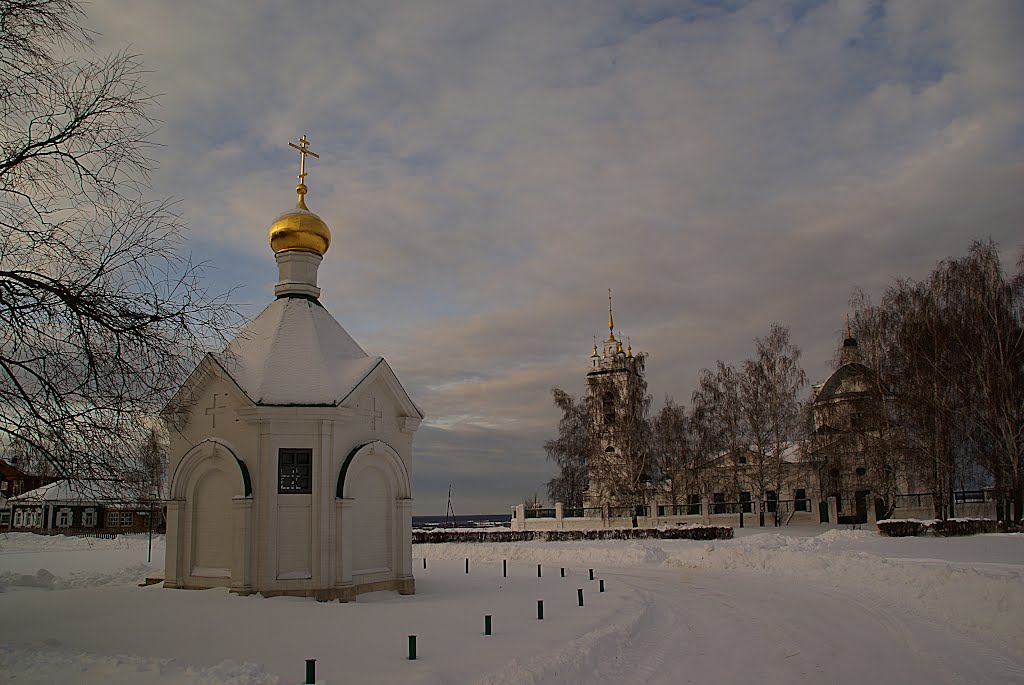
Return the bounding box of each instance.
[0,527,1024,685]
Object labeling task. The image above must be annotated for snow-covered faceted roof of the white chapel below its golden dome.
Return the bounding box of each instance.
[213,297,383,405]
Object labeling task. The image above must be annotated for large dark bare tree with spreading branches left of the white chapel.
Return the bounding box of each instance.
[0,0,236,478]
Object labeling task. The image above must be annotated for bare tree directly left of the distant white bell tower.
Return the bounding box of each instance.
[544,388,597,509]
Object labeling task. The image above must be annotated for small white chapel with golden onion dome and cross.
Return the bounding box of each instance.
[164,136,423,601]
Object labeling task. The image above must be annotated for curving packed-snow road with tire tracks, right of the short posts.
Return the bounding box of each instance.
[557,568,1024,685]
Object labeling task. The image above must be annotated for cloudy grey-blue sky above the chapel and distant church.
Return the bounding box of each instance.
[88,0,1024,514]
